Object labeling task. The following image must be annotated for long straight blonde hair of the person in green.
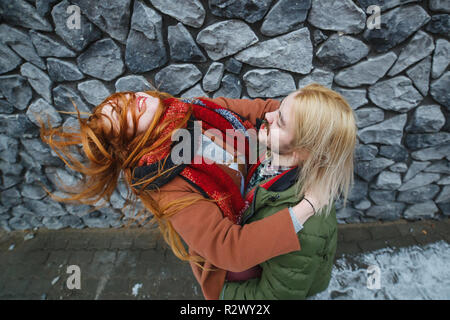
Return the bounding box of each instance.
[292,83,357,215]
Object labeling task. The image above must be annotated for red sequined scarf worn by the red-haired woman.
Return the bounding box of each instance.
[138,98,253,224]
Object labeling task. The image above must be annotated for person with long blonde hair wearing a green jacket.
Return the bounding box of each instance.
[221,84,357,299]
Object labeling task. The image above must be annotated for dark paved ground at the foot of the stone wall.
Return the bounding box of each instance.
[0,218,450,299]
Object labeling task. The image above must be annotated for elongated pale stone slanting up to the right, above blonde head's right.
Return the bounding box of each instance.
[335,52,397,88]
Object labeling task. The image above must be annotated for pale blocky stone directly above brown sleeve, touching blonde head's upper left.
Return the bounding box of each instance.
[243,69,296,98]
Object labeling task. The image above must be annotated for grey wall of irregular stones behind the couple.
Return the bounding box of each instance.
[0,0,450,230]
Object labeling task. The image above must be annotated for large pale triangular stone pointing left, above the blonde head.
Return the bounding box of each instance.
[235,28,313,74]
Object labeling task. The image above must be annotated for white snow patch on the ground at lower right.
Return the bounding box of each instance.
[309,241,450,300]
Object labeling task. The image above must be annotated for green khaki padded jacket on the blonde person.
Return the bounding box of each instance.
[220,169,337,300]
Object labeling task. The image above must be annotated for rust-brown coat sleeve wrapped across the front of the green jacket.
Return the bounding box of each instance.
[161,178,300,272]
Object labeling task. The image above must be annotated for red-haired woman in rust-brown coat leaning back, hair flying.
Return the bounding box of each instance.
[40,87,322,299]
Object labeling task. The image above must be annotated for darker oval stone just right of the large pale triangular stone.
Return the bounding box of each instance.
[316,34,370,69]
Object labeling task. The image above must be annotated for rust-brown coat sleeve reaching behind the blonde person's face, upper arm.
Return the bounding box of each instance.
[202,97,281,126]
